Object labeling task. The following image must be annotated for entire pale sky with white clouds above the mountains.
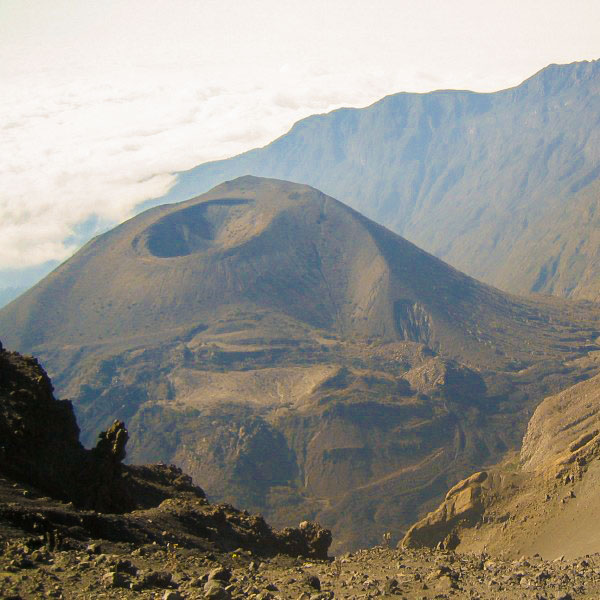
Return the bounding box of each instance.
[0,0,600,292]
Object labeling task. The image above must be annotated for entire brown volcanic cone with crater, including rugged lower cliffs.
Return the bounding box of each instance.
[0,176,600,549]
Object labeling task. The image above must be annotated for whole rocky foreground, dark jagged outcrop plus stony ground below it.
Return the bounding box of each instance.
[0,345,600,600]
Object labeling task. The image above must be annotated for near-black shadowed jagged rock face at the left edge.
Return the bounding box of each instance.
[0,345,193,512]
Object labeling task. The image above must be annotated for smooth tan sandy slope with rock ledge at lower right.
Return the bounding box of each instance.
[403,376,600,559]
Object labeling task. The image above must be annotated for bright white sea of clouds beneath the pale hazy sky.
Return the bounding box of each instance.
[0,65,464,269]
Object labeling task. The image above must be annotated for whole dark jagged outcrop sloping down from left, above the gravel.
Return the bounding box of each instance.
[0,345,331,559]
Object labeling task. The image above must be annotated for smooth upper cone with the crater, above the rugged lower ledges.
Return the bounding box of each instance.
[0,177,592,363]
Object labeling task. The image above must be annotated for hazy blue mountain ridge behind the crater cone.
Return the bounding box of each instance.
[159,61,600,300]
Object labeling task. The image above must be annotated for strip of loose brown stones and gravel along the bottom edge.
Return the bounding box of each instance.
[0,538,600,600]
